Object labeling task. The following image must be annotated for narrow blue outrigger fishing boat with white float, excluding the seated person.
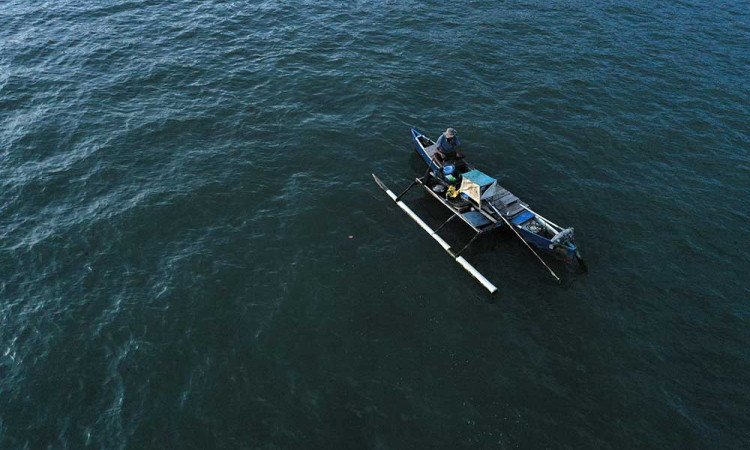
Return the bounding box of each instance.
[372,128,587,294]
